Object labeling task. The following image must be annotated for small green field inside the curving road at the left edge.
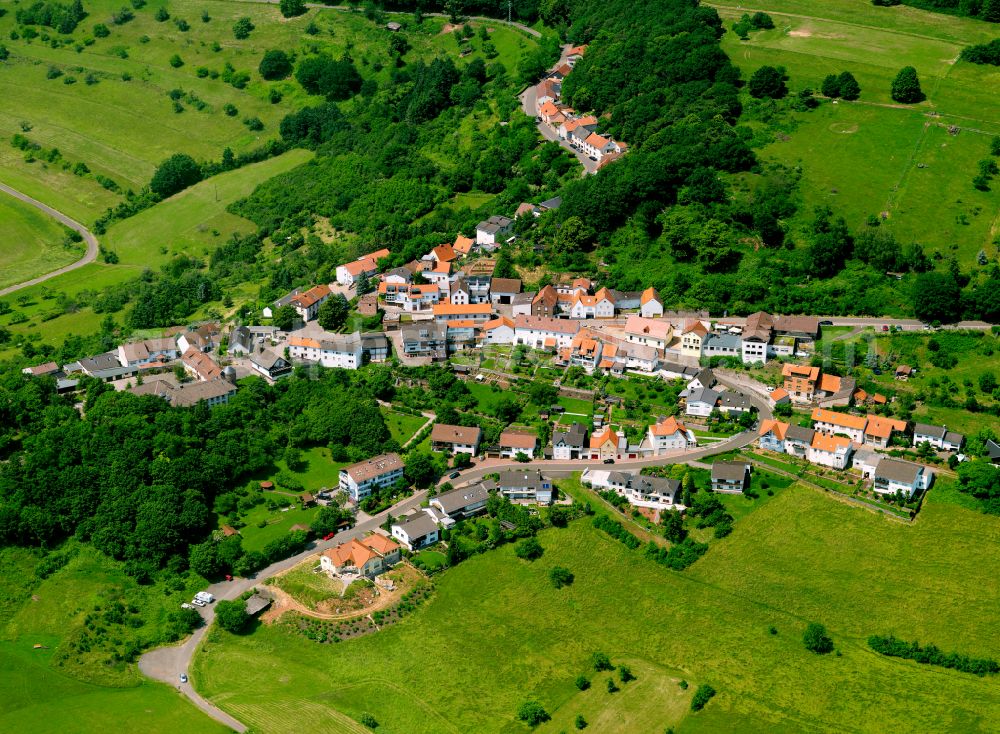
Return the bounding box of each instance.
[0,188,86,288]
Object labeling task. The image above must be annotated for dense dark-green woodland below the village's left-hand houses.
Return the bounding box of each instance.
[0,371,395,572]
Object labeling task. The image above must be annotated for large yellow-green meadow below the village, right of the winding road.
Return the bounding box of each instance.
[194,485,1000,734]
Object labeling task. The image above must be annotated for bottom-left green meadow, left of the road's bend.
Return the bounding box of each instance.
[0,549,227,734]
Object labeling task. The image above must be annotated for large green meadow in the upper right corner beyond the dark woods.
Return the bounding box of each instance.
[712,0,1000,266]
